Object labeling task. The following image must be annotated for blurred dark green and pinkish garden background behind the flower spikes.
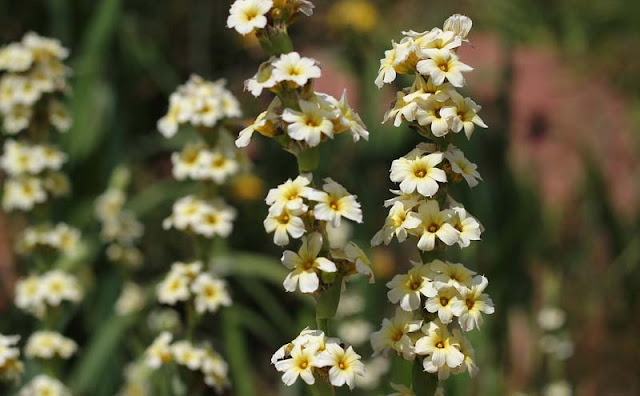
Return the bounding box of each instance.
[0,0,640,396]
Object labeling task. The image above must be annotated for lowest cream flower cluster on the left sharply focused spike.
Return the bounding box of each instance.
[271,328,364,389]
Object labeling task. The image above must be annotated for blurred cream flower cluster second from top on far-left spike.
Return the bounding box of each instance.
[0,139,70,211]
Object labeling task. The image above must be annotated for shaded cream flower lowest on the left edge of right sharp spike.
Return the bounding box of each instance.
[371,308,422,360]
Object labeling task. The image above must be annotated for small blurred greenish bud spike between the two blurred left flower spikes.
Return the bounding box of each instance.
[95,173,144,268]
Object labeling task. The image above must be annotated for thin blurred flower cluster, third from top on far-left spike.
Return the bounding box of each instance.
[16,223,80,256]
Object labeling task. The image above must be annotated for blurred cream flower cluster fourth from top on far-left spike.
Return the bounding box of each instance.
[15,269,82,318]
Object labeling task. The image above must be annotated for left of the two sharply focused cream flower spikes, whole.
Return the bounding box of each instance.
[227,0,373,388]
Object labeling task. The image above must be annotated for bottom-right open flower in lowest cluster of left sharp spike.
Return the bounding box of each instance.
[317,344,365,389]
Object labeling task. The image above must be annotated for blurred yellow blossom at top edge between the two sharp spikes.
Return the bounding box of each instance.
[327,0,380,33]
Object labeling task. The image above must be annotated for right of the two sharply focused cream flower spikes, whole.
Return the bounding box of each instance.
[372,15,494,391]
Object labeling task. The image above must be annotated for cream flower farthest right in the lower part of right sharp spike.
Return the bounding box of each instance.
[450,276,495,331]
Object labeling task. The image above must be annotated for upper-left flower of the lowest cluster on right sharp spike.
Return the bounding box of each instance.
[387,264,438,311]
